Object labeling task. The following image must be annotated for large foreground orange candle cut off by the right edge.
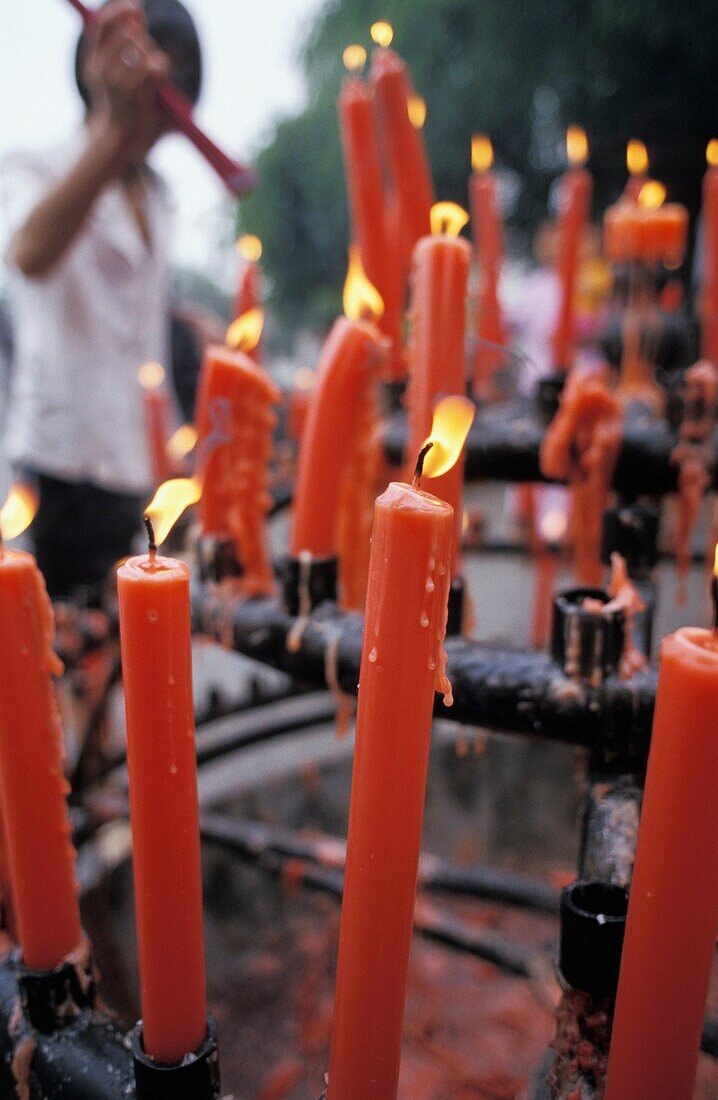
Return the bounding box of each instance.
[606,628,718,1100]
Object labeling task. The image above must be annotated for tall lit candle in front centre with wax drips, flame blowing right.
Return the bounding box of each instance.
[328,398,473,1100]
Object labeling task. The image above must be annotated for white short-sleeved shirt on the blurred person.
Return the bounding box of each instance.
[0,130,169,495]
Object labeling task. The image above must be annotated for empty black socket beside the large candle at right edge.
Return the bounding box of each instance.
[559,880,628,998]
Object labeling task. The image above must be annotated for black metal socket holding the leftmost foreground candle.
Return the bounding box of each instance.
[16,944,97,1035]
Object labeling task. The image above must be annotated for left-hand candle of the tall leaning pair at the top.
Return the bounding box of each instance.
[339,55,405,378]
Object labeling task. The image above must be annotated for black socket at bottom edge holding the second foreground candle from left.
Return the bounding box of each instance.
[132,1016,220,1100]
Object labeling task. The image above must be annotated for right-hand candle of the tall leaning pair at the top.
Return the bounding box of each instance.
[371,35,434,271]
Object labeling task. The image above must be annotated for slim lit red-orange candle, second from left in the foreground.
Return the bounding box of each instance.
[118,479,207,1063]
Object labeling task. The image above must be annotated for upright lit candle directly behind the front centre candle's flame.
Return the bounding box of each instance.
[408,202,472,578]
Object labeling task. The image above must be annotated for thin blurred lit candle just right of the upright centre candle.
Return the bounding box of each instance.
[470,134,506,397]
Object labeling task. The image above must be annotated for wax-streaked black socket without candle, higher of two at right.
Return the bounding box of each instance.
[551,589,626,681]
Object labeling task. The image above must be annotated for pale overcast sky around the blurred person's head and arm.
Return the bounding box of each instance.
[0,0,323,281]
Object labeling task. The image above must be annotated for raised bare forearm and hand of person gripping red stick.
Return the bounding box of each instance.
[9,0,169,278]
